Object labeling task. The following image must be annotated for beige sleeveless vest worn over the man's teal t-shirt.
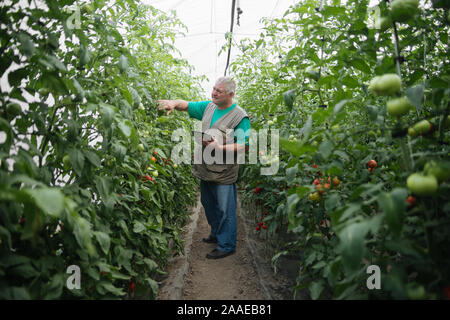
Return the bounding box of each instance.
[192,102,248,184]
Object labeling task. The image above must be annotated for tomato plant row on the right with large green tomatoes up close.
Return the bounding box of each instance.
[231,0,450,299]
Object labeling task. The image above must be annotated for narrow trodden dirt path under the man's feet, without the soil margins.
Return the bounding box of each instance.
[183,208,264,300]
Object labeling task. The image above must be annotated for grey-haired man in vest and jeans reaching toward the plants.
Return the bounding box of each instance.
[158,77,250,259]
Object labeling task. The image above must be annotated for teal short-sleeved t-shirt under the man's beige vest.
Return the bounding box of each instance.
[188,101,250,146]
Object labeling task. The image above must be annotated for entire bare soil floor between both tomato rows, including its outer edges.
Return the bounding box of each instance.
[157,197,306,300]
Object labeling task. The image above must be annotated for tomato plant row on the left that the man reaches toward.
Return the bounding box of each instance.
[0,0,201,299]
